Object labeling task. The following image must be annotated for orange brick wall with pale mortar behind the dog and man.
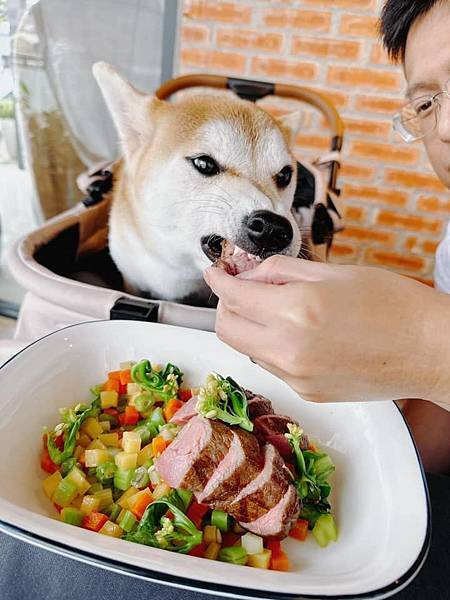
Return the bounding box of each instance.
[178,0,450,281]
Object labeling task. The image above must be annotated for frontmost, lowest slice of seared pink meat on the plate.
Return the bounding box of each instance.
[240,484,300,539]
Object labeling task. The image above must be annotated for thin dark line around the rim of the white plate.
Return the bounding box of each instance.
[0,319,432,600]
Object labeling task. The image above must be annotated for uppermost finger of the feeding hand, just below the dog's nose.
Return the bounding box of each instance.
[237,254,335,285]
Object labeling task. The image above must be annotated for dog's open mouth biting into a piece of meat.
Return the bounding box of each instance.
[200,235,263,275]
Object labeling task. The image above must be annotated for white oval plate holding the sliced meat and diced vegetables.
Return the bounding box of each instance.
[0,321,430,598]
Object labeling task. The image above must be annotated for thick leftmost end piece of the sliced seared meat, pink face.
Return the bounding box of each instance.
[155,416,233,492]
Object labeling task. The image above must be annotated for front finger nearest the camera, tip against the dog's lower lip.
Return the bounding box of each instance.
[204,267,285,323]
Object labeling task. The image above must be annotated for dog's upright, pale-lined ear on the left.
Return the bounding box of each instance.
[92,62,161,156]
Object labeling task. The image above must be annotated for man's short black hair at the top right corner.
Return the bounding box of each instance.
[380,0,442,62]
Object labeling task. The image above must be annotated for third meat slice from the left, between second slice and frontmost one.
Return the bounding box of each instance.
[227,444,289,522]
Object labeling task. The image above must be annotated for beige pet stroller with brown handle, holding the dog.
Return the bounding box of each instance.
[5,74,343,353]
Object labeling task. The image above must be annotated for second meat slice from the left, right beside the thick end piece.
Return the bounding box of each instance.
[197,427,263,510]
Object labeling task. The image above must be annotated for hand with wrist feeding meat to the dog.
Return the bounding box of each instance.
[205,256,450,402]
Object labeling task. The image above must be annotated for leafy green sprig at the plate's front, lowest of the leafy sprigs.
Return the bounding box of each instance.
[125,494,202,554]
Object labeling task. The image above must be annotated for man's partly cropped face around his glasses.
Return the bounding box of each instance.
[404,2,450,188]
